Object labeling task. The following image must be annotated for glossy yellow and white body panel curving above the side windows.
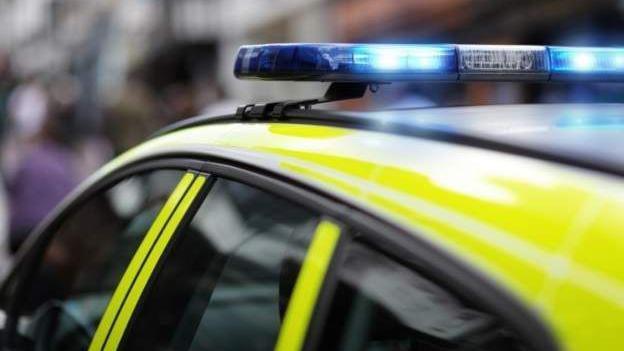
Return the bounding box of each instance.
[90,118,624,350]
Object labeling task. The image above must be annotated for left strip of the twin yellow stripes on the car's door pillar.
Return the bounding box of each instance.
[89,173,195,351]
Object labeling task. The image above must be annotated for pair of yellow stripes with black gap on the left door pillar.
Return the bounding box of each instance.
[89,173,206,351]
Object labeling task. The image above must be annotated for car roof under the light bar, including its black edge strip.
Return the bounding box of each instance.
[156,103,624,176]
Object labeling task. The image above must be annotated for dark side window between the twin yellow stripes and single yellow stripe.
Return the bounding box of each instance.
[122,179,319,351]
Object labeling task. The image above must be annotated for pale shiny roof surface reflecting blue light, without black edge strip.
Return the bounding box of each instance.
[346,104,624,175]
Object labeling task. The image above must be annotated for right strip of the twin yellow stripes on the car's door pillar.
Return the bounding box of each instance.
[104,176,206,350]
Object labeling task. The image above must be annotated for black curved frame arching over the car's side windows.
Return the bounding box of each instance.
[2,153,560,351]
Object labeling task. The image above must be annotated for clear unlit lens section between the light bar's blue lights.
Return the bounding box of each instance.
[458,45,548,74]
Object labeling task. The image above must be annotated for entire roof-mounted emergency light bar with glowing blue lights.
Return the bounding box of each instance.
[234,44,624,83]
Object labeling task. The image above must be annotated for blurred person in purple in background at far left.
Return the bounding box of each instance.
[8,93,78,253]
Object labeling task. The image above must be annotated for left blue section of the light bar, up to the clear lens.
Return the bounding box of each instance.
[234,44,457,82]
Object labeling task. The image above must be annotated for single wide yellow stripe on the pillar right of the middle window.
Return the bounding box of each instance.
[275,220,340,351]
